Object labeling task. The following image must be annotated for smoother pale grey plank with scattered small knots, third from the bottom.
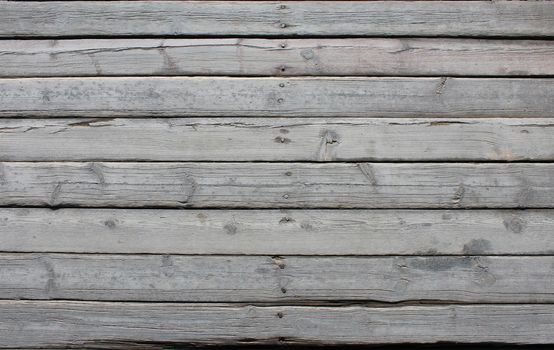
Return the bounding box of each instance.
[0,208,554,255]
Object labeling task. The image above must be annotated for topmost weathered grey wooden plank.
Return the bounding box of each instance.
[0,1,554,37]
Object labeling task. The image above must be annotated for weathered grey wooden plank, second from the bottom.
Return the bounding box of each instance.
[0,254,554,303]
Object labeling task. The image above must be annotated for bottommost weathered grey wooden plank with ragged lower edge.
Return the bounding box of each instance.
[0,301,554,347]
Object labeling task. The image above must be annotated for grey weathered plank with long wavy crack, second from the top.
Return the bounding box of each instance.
[0,38,554,77]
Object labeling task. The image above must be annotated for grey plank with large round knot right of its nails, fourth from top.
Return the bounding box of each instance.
[0,118,554,162]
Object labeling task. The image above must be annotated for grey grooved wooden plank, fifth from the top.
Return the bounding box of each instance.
[0,162,554,208]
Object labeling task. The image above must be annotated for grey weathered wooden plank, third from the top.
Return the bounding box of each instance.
[0,77,554,117]
